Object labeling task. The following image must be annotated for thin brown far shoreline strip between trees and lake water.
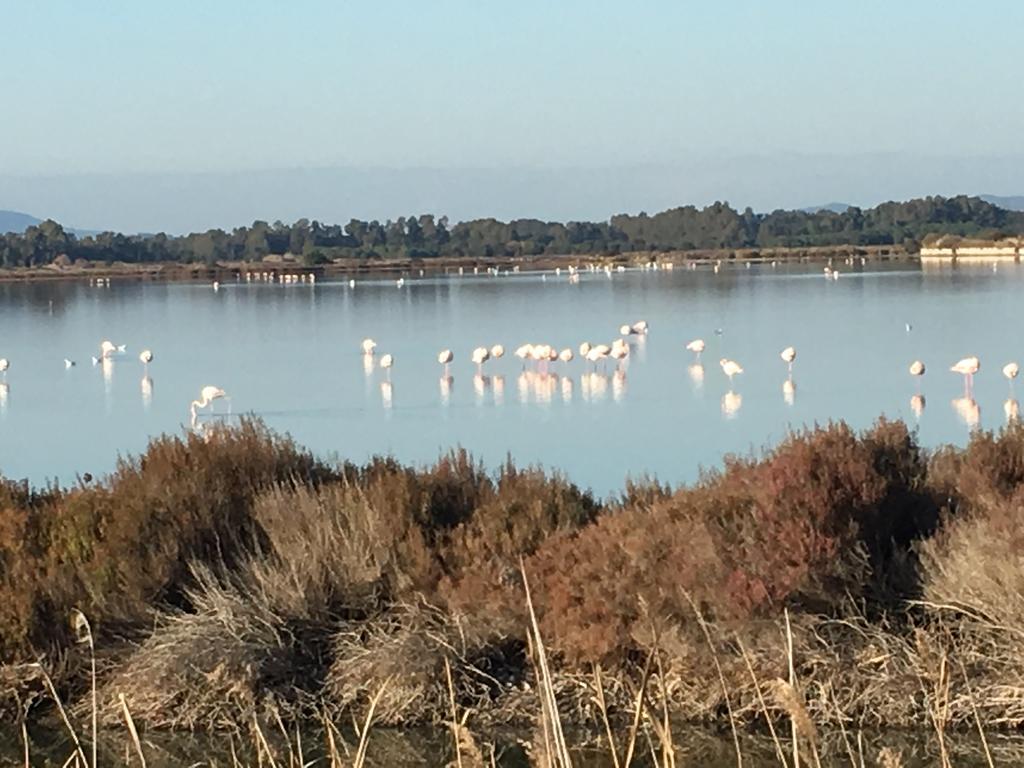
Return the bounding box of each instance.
[0,245,920,283]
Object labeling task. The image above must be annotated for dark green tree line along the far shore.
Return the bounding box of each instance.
[0,196,1024,267]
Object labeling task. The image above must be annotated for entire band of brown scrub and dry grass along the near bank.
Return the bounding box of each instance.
[9,421,1024,728]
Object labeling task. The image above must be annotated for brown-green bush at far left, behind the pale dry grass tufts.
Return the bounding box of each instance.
[0,421,334,658]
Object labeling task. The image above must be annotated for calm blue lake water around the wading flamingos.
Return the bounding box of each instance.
[0,263,1024,495]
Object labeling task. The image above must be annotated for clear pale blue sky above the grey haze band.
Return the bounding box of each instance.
[0,0,1024,230]
